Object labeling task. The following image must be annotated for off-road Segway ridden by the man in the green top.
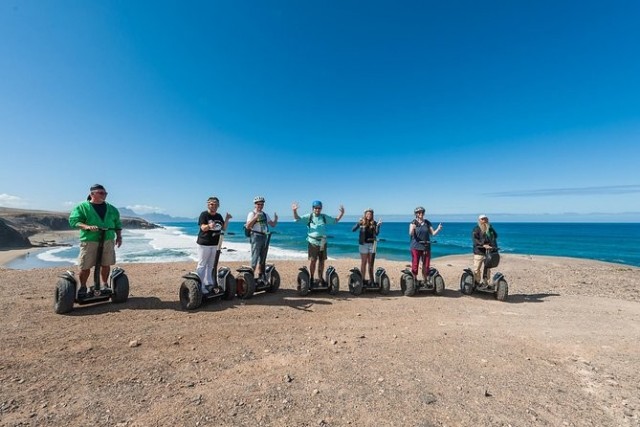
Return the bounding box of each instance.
[53,228,129,314]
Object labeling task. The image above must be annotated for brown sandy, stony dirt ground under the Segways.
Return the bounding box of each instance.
[0,255,640,427]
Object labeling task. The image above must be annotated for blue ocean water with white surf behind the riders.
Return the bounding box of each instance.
[8,220,640,269]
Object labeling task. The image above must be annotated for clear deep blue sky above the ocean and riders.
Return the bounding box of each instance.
[0,0,640,221]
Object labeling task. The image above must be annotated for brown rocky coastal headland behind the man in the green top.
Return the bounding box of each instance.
[0,207,159,249]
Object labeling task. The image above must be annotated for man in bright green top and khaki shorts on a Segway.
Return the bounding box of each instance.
[69,184,122,297]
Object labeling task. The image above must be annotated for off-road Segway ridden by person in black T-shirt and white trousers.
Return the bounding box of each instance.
[179,226,236,310]
